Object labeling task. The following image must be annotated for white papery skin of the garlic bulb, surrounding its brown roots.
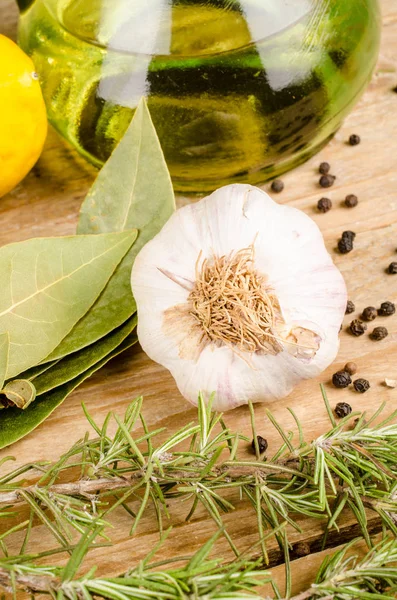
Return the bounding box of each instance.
[131,184,347,411]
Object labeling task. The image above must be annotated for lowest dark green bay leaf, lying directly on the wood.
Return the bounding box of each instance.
[0,334,137,450]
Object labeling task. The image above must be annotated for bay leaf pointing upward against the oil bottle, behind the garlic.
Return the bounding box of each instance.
[48,100,175,360]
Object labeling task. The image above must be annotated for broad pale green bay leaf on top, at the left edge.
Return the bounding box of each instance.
[0,231,136,379]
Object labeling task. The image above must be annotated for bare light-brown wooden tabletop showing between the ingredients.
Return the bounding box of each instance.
[0,0,397,592]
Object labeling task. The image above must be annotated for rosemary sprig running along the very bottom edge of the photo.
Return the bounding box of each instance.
[0,529,397,600]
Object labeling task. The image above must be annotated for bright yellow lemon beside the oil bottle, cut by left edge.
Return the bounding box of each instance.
[0,35,47,197]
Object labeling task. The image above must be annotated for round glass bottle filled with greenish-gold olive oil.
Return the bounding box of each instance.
[19,0,380,192]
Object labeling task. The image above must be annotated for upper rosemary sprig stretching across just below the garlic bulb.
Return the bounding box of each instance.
[0,397,397,566]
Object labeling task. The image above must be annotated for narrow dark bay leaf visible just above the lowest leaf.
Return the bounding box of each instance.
[33,316,137,395]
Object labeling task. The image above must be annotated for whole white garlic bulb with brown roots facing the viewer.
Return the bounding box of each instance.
[131,184,347,410]
